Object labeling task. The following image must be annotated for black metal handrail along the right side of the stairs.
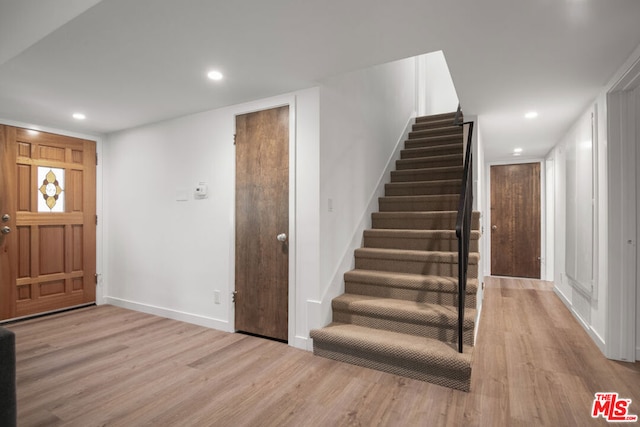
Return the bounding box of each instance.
[453,106,473,353]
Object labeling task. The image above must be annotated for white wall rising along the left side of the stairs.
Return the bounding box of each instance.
[316,58,417,327]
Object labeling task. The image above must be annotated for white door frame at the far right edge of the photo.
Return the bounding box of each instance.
[605,52,640,362]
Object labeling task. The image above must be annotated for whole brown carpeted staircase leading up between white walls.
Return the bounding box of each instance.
[311,113,480,391]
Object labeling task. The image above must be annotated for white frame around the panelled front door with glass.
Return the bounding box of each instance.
[0,117,108,310]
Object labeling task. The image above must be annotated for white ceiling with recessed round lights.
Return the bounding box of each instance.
[0,0,640,160]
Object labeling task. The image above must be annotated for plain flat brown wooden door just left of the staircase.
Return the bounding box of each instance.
[235,106,289,341]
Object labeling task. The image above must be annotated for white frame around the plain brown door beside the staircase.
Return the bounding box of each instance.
[229,95,298,347]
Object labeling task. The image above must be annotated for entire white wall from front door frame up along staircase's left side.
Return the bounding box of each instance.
[104,53,456,349]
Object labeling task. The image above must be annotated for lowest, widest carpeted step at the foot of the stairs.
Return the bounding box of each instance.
[311,323,473,391]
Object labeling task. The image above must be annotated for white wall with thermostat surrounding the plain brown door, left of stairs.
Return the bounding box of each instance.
[104,88,319,348]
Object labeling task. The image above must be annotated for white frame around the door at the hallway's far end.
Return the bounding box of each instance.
[482,157,553,280]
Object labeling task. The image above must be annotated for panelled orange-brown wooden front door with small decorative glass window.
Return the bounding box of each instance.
[0,125,96,320]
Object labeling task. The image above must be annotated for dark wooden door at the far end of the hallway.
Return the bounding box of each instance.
[491,163,540,279]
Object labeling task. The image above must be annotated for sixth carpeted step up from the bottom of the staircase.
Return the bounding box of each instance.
[371,211,480,230]
